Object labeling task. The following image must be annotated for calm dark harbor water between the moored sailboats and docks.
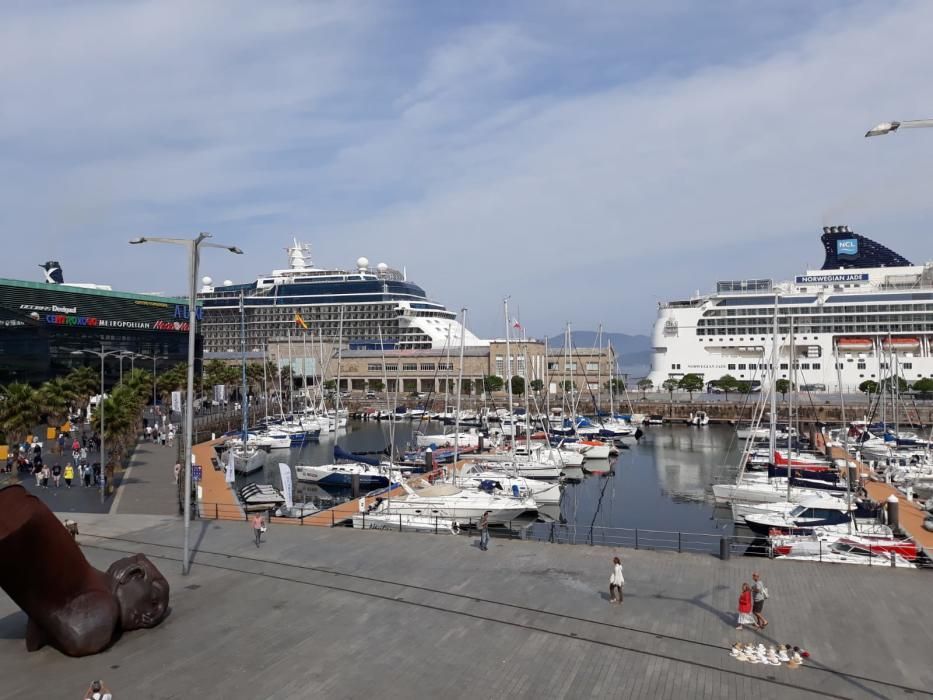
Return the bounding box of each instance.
[238,421,740,535]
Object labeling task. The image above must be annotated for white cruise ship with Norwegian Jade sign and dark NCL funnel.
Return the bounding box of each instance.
[648,226,933,391]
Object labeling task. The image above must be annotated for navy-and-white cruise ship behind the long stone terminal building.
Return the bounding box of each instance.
[198,240,488,353]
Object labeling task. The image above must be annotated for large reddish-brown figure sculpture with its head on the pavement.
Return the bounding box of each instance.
[0,486,169,656]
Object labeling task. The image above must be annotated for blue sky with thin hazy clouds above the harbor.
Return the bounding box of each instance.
[0,0,933,336]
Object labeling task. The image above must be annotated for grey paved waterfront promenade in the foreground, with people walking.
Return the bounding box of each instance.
[0,513,933,700]
